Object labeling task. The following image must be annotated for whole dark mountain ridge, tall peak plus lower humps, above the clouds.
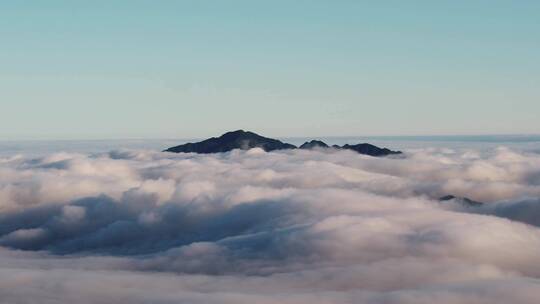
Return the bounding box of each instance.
[165,130,402,156]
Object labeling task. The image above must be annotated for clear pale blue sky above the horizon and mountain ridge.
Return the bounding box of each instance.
[0,0,540,139]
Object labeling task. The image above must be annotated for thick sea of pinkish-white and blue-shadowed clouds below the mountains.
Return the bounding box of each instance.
[0,148,540,304]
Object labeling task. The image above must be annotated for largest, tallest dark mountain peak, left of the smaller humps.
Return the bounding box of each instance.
[165,130,296,153]
